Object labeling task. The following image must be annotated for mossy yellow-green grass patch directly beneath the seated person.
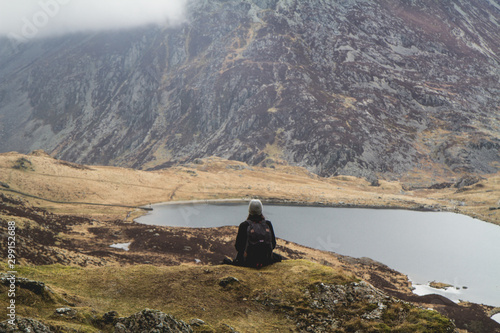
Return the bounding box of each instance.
[0,260,356,332]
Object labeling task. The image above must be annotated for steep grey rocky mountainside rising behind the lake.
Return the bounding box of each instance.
[0,0,500,177]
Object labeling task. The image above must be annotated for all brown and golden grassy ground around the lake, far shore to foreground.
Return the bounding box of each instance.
[0,152,500,332]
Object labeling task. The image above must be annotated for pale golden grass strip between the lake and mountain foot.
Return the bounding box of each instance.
[0,152,500,224]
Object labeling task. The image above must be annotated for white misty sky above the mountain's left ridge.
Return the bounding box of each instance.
[0,0,187,41]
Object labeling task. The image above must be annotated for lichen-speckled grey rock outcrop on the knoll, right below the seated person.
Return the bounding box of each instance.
[256,281,455,332]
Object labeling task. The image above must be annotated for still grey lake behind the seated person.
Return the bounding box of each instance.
[136,204,500,307]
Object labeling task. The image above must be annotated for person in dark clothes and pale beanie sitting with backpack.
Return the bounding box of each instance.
[224,199,282,268]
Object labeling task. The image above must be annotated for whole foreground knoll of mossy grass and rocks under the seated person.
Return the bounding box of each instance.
[0,260,453,332]
